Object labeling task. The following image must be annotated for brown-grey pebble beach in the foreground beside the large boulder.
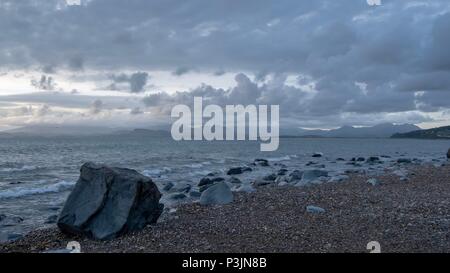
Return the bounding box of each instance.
[0,164,450,253]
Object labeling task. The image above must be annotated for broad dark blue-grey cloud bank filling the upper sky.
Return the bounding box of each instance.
[0,0,450,125]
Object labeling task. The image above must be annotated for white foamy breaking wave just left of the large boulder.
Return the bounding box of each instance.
[0,181,75,199]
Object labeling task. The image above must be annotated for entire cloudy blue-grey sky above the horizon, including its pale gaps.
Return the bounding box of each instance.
[0,0,450,130]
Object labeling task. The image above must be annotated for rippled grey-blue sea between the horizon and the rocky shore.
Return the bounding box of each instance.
[0,135,450,240]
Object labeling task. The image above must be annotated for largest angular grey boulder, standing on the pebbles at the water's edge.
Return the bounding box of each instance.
[57,163,164,240]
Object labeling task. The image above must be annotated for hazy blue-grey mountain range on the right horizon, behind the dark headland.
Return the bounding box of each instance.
[282,123,420,138]
